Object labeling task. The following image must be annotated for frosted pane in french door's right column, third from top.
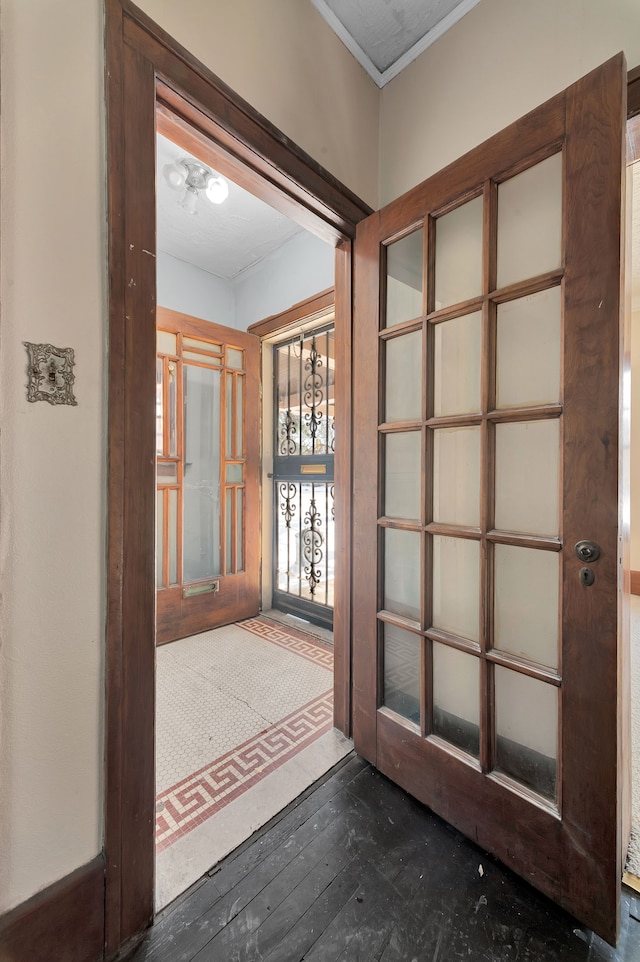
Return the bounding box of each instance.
[495,418,560,537]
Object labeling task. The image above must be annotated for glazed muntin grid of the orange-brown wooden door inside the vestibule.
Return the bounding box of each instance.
[156,328,246,590]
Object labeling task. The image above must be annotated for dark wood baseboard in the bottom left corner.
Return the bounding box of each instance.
[0,855,105,962]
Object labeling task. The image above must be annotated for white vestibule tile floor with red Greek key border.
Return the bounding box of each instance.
[156,617,352,910]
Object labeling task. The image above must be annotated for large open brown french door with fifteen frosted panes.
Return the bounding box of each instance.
[353,56,626,941]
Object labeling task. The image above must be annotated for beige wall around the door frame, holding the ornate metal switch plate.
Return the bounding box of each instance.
[0,0,379,912]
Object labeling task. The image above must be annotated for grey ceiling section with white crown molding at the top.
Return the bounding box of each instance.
[311,0,480,87]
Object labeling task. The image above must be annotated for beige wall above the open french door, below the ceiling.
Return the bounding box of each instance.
[380,0,640,203]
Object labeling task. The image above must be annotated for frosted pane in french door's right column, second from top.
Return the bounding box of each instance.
[496,287,561,408]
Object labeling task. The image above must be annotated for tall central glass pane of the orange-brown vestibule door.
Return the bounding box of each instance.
[183,364,220,584]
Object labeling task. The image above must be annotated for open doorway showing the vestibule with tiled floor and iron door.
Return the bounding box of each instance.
[155,111,352,911]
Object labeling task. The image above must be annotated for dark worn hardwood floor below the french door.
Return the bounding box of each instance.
[131,755,640,962]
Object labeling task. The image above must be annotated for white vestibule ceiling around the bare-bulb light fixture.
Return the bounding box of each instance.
[156,134,301,280]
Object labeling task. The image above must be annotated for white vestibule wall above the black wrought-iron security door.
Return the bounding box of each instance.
[234,231,335,330]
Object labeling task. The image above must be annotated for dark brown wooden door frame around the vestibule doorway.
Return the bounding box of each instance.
[105,0,371,957]
